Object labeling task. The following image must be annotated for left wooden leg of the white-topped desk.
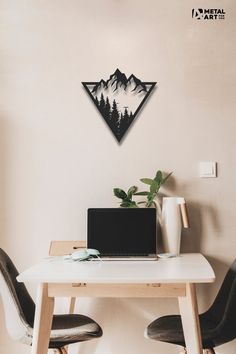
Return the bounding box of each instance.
[31,284,54,354]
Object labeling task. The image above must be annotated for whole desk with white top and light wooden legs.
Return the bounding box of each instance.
[17,253,215,354]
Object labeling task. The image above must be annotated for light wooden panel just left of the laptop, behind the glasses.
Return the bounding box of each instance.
[49,241,86,256]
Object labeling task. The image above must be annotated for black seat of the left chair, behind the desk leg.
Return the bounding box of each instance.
[24,314,102,349]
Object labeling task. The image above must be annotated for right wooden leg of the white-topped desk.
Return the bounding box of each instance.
[178,283,202,354]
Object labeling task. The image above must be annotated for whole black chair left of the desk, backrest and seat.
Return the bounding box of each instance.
[0,249,102,354]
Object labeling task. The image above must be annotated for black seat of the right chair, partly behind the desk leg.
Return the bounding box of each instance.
[147,315,216,349]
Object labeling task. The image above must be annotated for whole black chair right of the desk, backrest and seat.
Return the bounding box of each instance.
[146,260,236,353]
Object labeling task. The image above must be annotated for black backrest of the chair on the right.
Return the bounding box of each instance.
[205,260,236,344]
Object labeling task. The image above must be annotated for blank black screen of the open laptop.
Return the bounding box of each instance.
[87,208,157,257]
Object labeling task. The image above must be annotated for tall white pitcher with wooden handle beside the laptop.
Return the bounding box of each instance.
[160,197,188,256]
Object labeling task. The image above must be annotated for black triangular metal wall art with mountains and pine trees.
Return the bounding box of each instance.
[82,69,156,142]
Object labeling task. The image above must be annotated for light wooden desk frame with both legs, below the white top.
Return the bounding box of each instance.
[32,283,202,354]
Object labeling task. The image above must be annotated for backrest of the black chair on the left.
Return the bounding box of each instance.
[0,248,35,344]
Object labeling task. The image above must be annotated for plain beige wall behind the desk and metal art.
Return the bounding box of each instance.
[0,0,236,354]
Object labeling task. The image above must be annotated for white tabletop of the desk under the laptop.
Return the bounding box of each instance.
[17,253,215,284]
